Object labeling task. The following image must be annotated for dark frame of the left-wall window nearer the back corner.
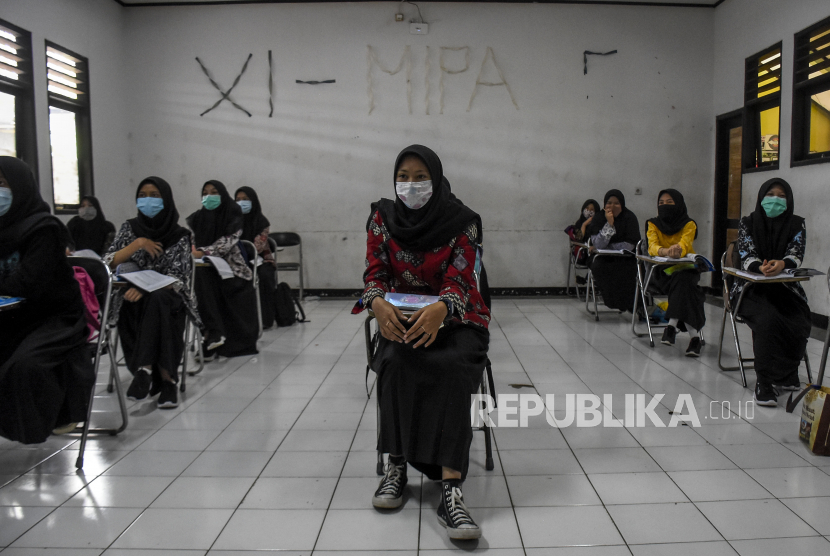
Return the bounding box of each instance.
[44,39,95,214]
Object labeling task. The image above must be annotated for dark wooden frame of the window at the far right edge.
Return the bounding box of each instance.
[790,17,830,168]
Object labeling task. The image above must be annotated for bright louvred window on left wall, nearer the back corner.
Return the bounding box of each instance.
[46,41,93,214]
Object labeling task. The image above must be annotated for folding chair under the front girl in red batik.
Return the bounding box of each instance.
[363,248,496,475]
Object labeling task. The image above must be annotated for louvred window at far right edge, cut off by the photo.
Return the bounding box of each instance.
[791,17,830,166]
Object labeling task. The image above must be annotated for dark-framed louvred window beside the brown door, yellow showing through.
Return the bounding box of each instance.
[742,43,781,172]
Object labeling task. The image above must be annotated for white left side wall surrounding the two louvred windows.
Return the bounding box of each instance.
[0,0,129,224]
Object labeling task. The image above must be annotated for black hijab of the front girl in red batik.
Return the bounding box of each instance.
[366,145,482,251]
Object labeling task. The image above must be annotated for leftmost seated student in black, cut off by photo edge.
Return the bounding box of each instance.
[0,156,95,444]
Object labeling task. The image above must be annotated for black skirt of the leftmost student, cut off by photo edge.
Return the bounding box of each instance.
[0,309,95,444]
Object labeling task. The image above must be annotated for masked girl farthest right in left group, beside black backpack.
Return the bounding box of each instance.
[234,187,277,328]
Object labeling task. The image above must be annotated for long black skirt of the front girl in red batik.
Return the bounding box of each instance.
[372,323,490,480]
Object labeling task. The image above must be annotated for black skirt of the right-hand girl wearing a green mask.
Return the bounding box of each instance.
[738,284,812,384]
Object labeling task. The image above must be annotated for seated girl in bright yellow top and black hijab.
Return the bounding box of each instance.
[646,189,706,357]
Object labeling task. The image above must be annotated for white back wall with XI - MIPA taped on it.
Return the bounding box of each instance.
[118,0,720,289]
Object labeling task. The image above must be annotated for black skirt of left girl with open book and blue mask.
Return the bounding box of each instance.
[118,290,187,384]
